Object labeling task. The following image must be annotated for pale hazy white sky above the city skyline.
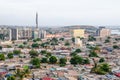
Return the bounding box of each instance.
[0,0,120,26]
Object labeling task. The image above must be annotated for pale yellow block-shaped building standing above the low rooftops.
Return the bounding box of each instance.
[72,29,85,38]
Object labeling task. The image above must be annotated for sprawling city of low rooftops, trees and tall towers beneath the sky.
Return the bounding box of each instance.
[0,0,120,80]
